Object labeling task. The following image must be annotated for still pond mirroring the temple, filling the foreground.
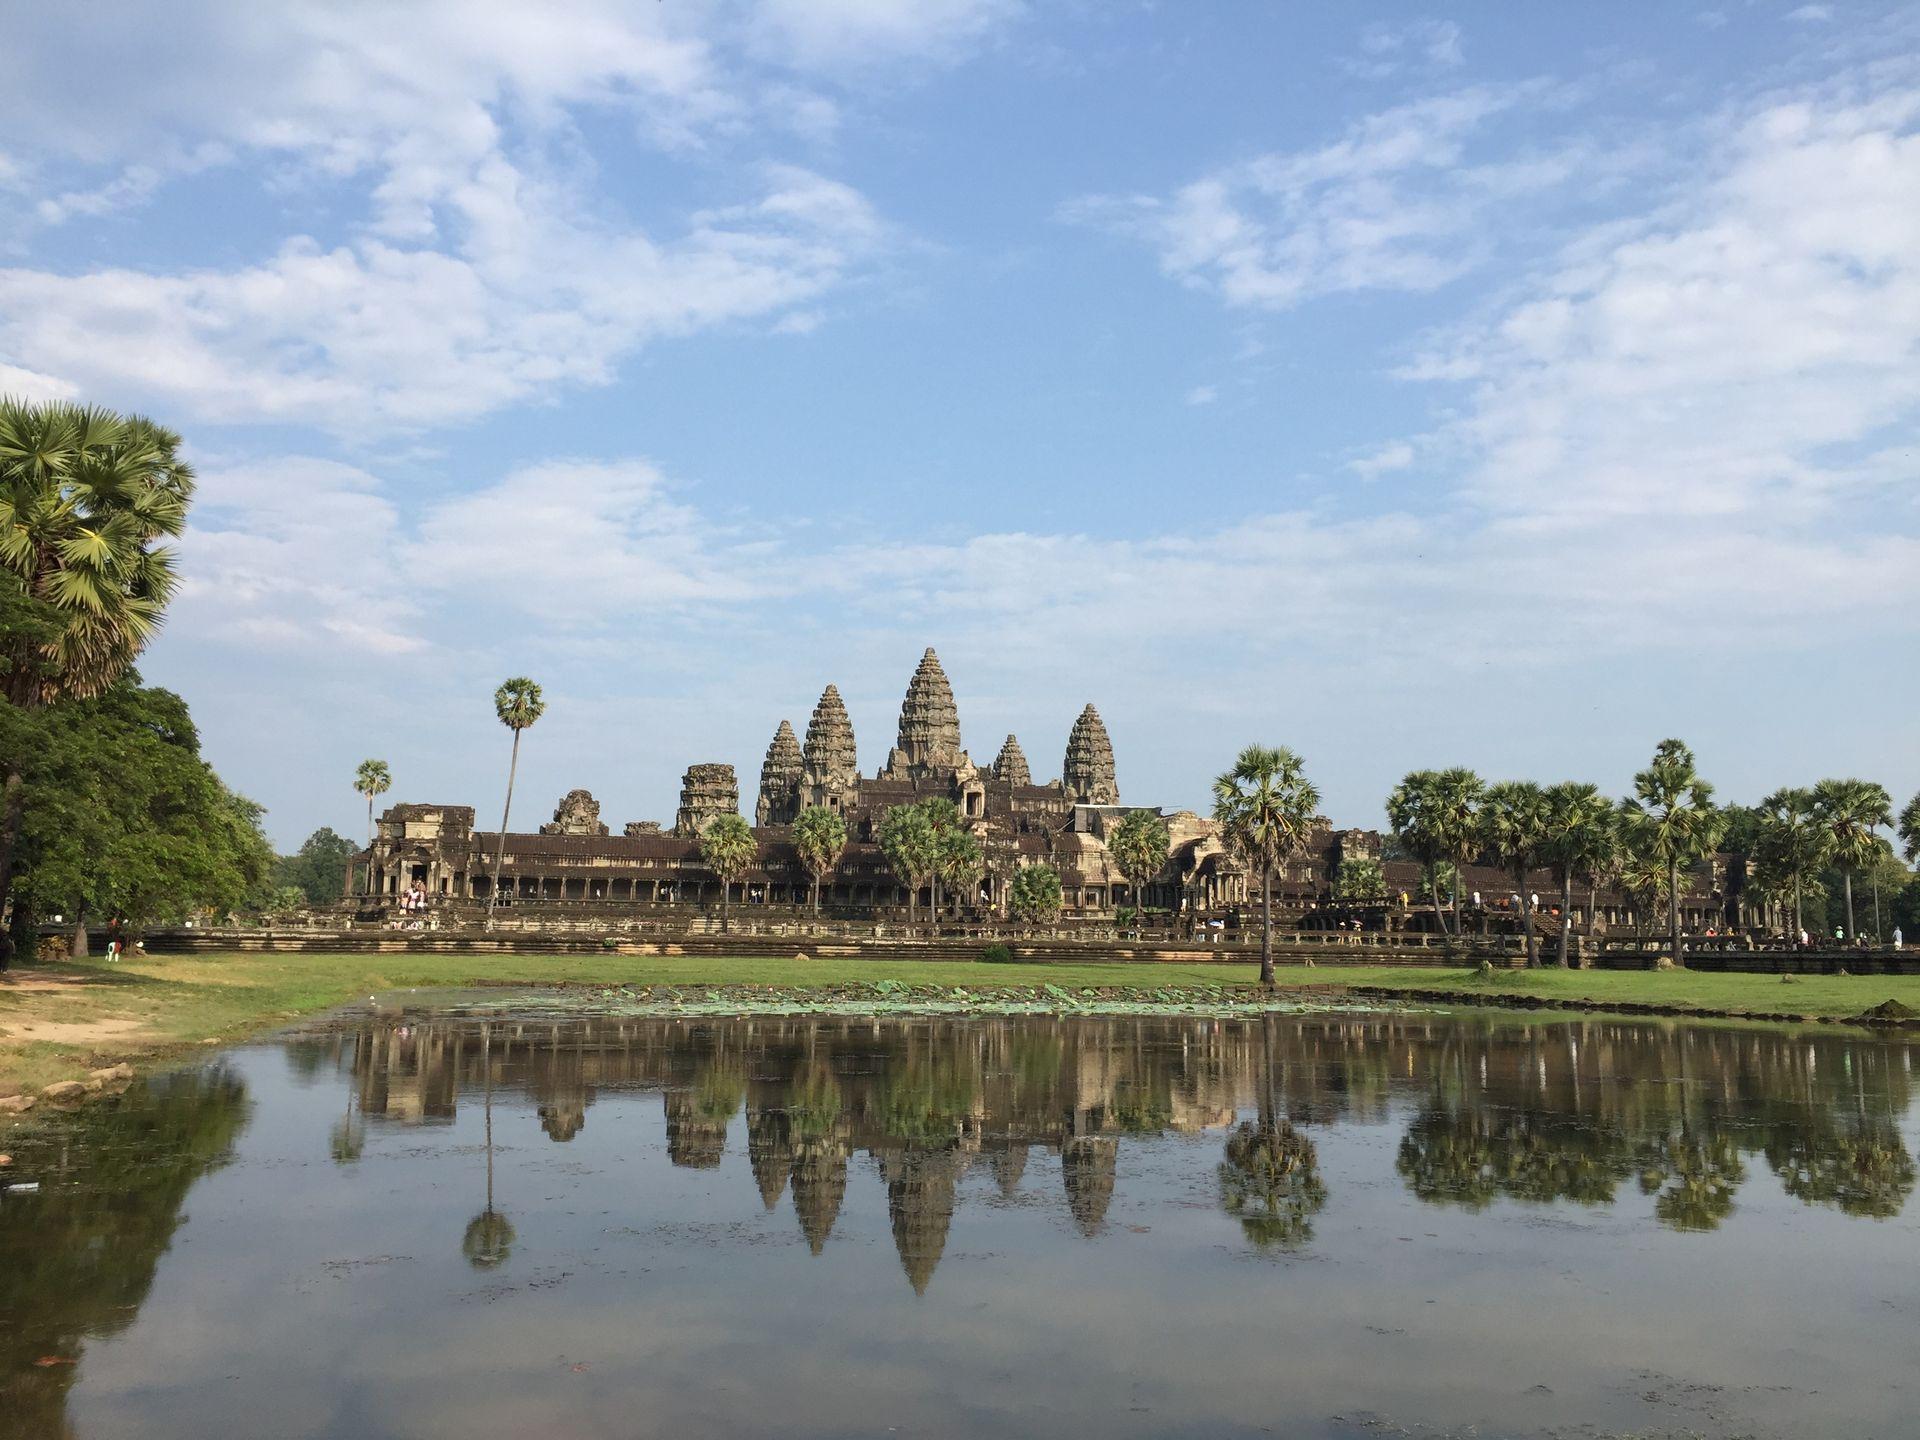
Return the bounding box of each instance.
[0,1000,1920,1440]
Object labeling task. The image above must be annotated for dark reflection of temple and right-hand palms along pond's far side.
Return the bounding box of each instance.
[322,1016,1914,1288]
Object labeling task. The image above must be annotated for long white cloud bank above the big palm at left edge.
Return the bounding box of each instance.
[0,169,883,430]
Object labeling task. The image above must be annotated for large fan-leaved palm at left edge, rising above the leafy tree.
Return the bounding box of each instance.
[0,397,194,952]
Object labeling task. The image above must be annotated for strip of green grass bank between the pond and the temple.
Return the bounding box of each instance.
[0,954,1920,1096]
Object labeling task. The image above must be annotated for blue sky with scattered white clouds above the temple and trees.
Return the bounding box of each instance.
[0,0,1920,845]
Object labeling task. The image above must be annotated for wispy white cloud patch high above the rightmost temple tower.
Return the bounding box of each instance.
[1062,86,1574,309]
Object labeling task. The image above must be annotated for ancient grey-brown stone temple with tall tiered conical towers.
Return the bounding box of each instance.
[355,649,1720,925]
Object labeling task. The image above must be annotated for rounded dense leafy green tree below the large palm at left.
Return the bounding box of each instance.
[17,672,275,940]
